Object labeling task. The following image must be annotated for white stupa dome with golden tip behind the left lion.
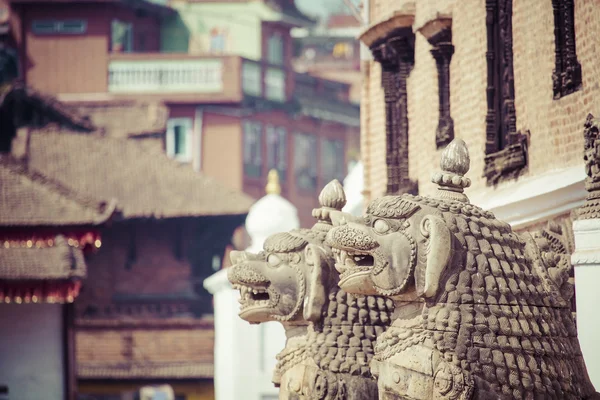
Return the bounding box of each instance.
[246,169,300,252]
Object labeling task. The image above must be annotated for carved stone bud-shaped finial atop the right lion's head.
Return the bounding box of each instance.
[431,139,471,203]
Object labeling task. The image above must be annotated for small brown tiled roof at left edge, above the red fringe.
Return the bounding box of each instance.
[0,156,114,227]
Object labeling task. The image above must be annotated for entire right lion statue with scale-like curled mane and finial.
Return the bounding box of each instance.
[327,141,596,399]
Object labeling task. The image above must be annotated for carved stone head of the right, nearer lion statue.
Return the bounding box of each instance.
[327,196,454,297]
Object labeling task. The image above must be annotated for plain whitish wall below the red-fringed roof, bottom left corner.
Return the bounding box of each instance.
[0,304,65,400]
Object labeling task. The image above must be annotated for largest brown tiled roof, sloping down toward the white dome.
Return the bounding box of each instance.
[29,127,253,218]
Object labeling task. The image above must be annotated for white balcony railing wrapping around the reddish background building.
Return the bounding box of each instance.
[107,53,348,108]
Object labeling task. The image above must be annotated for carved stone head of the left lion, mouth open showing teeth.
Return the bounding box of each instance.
[228,229,333,323]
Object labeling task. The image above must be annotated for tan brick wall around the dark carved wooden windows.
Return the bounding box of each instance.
[361,0,600,209]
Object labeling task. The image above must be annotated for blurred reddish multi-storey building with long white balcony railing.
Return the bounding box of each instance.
[4,0,359,226]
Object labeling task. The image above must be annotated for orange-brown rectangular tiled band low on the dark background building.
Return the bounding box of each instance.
[75,318,214,379]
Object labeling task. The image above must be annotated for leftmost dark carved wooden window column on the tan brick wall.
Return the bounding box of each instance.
[371,28,417,194]
